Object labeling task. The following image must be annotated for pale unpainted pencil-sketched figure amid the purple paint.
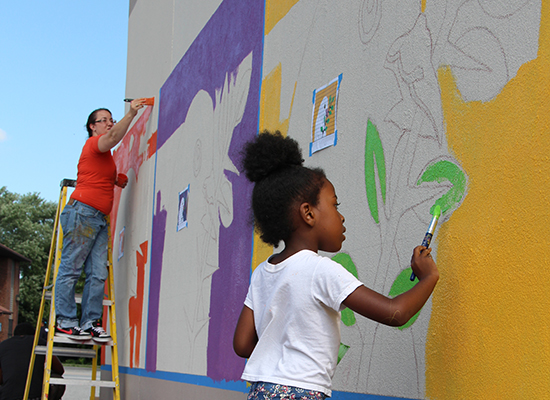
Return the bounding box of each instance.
[182,53,252,370]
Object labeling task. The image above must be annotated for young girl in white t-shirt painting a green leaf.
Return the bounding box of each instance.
[233,131,439,399]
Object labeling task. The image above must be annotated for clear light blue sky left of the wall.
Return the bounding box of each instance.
[0,0,129,203]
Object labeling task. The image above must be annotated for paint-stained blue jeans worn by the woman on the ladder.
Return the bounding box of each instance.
[55,201,109,330]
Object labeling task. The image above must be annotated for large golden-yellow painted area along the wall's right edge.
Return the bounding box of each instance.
[432,1,550,399]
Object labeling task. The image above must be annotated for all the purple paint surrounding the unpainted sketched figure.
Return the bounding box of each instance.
[150,0,264,381]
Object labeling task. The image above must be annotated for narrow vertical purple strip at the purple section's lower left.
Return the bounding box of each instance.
[145,190,168,372]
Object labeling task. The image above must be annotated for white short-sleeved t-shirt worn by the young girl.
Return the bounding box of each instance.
[242,250,362,396]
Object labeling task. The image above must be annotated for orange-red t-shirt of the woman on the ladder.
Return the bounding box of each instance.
[71,136,117,215]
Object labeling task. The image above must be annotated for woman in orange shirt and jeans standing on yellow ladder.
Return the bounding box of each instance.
[55,99,146,343]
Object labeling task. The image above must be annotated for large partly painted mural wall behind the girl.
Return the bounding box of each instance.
[101,0,550,399]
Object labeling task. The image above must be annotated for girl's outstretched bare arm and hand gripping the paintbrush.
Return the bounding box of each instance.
[343,246,439,326]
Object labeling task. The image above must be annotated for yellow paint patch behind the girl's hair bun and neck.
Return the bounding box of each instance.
[252,64,296,270]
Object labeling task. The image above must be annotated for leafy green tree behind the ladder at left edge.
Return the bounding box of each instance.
[0,186,57,324]
